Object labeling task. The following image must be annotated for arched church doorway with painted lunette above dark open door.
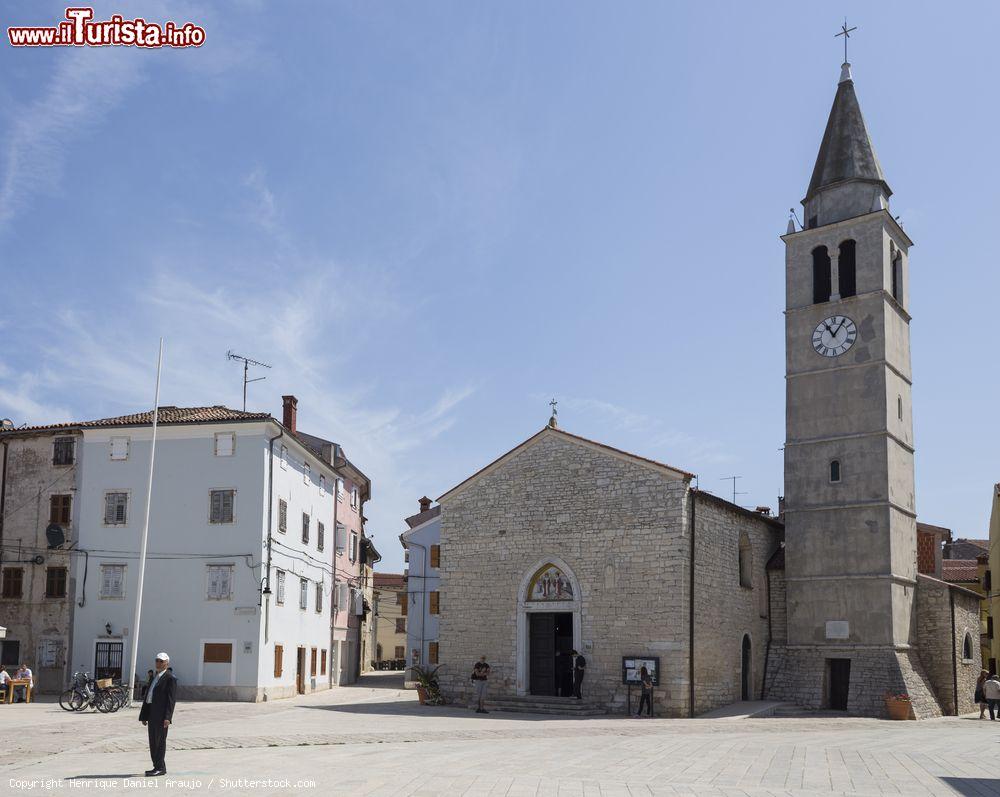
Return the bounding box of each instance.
[517,557,583,697]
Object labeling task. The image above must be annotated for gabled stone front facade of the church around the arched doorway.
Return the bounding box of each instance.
[439,433,688,716]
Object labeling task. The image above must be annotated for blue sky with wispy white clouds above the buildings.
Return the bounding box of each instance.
[0,0,1000,572]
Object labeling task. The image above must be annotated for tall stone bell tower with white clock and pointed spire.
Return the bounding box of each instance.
[770,63,933,715]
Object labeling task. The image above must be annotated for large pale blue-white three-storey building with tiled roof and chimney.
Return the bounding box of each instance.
[72,397,337,701]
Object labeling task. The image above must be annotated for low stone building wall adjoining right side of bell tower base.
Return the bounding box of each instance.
[914,575,982,714]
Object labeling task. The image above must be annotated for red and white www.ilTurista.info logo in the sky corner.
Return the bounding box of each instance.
[7,8,205,48]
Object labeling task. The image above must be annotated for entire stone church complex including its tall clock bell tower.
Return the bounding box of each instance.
[438,57,981,719]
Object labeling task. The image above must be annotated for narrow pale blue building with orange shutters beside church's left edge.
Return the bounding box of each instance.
[399,498,441,682]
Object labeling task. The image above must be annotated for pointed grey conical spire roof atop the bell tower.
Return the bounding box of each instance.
[806,64,892,201]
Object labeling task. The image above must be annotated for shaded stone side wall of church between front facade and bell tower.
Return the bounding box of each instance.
[694,495,780,715]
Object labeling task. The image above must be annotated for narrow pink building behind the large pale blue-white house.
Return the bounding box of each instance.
[282,396,371,686]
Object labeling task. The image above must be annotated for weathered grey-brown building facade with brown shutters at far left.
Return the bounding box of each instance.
[0,427,82,693]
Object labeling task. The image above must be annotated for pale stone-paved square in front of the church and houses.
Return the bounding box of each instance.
[0,675,1000,797]
